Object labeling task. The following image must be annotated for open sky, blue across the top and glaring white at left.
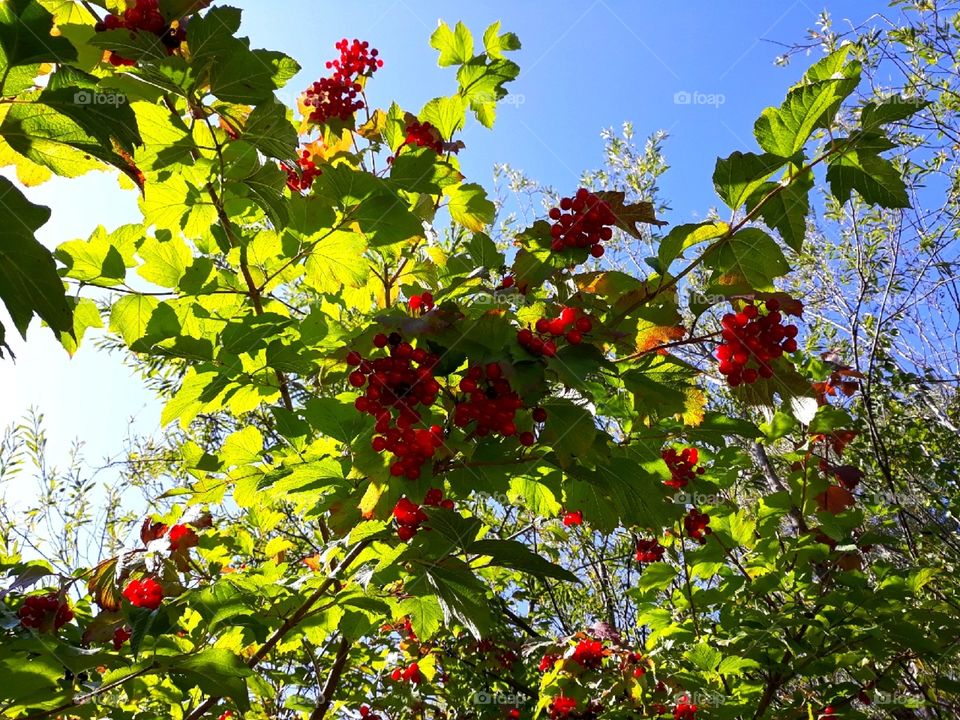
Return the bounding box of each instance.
[0,0,886,496]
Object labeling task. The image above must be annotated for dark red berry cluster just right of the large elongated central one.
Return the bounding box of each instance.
[453,363,545,447]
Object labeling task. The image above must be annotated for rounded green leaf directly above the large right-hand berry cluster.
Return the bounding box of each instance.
[706,228,790,291]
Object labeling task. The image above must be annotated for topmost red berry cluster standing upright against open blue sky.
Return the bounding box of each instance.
[303,38,383,124]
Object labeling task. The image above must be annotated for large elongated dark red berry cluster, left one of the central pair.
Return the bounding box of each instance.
[347,333,443,480]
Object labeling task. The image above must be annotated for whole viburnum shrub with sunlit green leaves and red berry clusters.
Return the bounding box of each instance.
[0,5,932,720]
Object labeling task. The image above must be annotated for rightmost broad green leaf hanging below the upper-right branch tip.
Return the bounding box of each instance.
[827,150,910,208]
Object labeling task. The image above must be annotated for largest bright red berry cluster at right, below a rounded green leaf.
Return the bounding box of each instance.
[714,298,803,387]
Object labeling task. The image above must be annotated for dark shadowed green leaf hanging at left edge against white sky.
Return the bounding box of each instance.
[0,177,73,337]
